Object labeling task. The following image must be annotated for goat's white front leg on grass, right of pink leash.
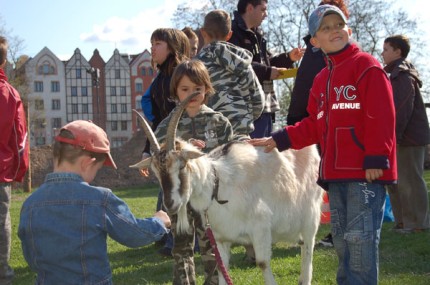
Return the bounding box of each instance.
[251,229,276,285]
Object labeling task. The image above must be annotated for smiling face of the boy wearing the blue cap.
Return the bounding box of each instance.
[311,14,351,54]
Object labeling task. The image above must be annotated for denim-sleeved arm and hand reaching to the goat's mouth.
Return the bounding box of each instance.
[105,193,170,247]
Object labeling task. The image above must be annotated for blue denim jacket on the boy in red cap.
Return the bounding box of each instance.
[18,173,168,285]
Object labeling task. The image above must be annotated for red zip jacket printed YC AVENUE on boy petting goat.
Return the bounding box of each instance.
[272,44,397,186]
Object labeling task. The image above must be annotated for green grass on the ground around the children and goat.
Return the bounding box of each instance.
[11,171,430,285]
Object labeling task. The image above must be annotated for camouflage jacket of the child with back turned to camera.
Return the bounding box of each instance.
[197,41,265,136]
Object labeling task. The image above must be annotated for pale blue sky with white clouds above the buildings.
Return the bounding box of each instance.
[0,0,430,61]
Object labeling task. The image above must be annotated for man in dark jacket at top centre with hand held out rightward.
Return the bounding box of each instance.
[229,0,304,138]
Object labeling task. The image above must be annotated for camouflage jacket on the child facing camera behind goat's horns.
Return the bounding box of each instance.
[155,105,233,153]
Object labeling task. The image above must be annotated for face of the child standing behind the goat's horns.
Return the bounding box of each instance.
[176,75,206,111]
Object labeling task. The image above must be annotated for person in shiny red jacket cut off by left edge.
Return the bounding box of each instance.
[0,36,29,285]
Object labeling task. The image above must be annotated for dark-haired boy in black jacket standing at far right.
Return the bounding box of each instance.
[382,35,430,233]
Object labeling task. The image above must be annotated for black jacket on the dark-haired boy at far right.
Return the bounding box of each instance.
[384,58,430,146]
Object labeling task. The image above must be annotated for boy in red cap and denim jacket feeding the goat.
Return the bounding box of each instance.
[18,120,170,284]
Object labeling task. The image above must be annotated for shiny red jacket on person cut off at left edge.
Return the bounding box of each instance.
[0,69,29,183]
